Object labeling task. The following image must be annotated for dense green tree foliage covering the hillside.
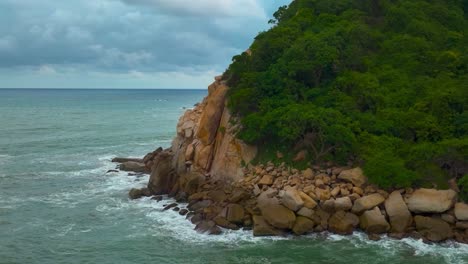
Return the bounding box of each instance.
[224,0,468,192]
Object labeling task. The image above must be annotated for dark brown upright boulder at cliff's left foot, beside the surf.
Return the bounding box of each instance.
[148,151,177,195]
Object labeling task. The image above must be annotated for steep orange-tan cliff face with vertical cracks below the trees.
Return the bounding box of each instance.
[172,77,257,182]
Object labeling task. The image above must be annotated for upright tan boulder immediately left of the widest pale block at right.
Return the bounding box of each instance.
[385,191,413,233]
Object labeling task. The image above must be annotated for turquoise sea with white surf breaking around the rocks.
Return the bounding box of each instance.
[0,90,468,264]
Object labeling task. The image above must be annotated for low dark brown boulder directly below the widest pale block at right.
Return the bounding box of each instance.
[414,215,453,242]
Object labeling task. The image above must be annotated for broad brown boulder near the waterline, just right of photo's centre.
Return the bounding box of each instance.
[260,204,296,229]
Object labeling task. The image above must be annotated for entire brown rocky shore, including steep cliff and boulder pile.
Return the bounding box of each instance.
[114,77,468,243]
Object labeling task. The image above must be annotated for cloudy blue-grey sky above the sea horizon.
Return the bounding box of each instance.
[0,0,291,88]
